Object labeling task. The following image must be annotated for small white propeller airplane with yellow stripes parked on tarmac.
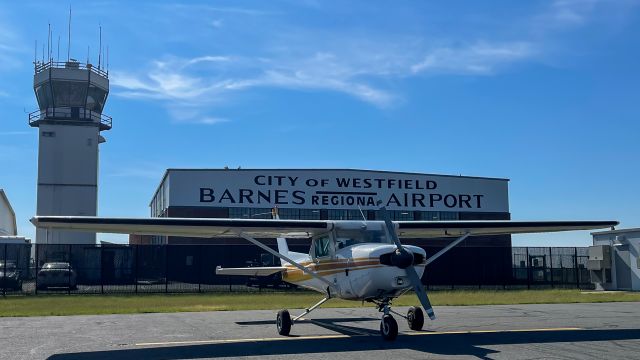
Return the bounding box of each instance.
[31,207,618,340]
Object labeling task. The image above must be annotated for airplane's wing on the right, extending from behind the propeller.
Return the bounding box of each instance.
[395,220,618,238]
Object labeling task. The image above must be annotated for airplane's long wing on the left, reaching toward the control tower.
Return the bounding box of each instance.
[31,216,333,238]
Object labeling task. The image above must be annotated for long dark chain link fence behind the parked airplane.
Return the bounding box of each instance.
[0,244,592,296]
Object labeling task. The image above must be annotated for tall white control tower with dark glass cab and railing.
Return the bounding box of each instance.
[29,59,111,245]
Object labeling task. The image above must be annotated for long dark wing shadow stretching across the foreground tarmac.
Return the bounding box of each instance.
[48,329,640,360]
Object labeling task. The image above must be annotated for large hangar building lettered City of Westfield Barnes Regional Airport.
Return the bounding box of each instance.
[146,169,511,250]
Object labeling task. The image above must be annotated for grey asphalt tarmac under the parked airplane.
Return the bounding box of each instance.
[0,301,640,360]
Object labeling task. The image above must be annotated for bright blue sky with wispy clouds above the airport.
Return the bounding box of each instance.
[0,0,640,246]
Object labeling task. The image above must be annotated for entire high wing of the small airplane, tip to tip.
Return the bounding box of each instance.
[31,216,618,238]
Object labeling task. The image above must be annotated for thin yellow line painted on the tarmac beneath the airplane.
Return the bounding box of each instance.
[135,327,584,346]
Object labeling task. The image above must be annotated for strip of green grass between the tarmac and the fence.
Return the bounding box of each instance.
[0,289,640,317]
